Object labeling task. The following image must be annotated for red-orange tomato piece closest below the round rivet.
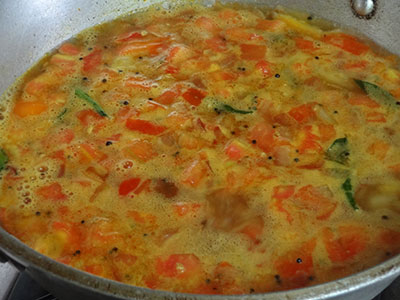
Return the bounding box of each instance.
[323,33,369,55]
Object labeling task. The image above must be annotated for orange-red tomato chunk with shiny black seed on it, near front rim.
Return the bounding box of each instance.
[275,239,316,288]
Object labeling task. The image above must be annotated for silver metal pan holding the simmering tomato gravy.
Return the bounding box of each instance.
[0,0,400,300]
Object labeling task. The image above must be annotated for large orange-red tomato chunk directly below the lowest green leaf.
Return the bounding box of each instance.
[323,225,368,263]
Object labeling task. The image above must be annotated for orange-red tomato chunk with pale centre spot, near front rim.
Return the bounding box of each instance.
[156,254,202,279]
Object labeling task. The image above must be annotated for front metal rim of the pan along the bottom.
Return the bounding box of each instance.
[0,228,400,300]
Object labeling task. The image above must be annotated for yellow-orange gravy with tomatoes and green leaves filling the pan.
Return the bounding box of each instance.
[0,0,400,294]
